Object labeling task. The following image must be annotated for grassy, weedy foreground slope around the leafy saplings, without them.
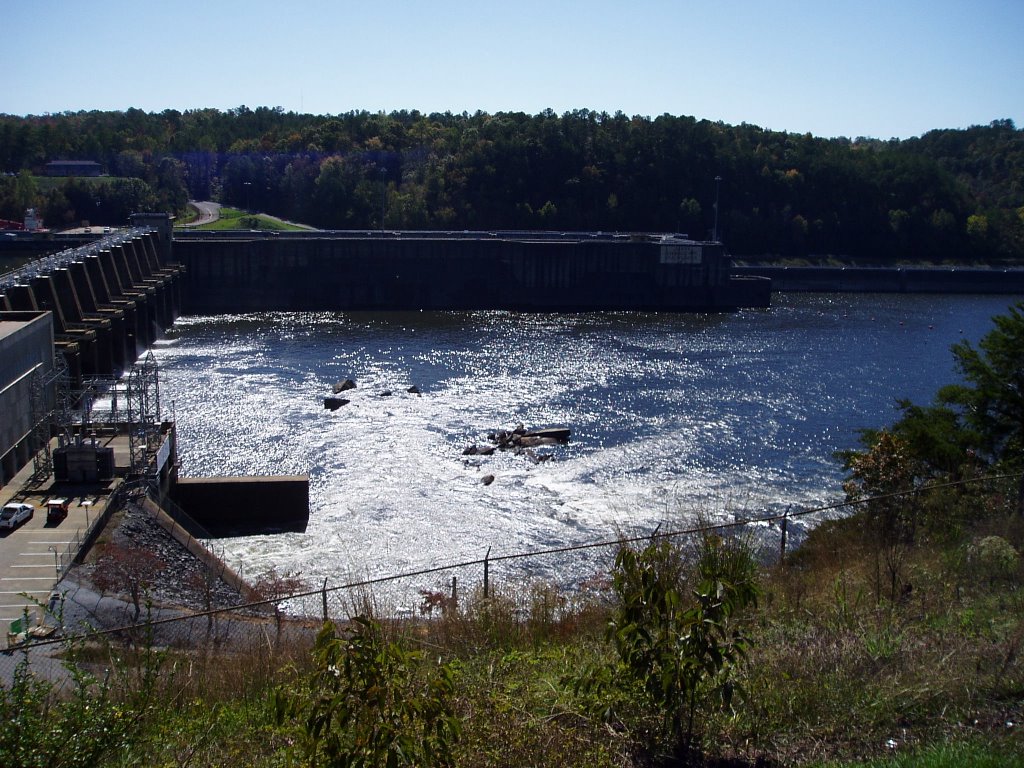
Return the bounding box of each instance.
[0,473,1024,766]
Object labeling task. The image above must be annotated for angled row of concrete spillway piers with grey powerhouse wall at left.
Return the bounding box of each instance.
[0,215,184,487]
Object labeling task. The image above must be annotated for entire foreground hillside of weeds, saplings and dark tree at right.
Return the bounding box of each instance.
[0,309,1024,768]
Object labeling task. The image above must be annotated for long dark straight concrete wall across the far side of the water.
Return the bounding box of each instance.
[174,232,770,314]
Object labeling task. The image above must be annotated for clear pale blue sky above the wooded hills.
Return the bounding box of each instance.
[0,0,1024,138]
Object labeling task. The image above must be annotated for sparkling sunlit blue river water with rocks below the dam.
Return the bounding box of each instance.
[149,294,1013,584]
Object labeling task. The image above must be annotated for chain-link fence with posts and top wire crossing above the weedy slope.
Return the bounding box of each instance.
[0,475,1017,685]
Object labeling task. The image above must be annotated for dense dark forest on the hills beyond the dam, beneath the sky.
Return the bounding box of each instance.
[0,106,1024,261]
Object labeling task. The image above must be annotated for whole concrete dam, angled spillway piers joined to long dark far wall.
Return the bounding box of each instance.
[0,219,771,485]
